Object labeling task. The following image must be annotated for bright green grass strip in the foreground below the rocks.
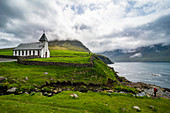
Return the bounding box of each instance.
[0,91,170,113]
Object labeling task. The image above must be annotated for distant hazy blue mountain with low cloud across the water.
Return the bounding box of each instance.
[99,44,170,62]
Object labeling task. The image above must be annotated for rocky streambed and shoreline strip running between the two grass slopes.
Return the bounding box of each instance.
[0,68,170,99]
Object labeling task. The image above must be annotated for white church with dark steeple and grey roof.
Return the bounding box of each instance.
[13,31,50,58]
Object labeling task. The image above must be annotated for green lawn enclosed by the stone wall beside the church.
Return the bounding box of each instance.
[27,56,90,64]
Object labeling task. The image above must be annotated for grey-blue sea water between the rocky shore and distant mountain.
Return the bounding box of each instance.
[108,62,170,88]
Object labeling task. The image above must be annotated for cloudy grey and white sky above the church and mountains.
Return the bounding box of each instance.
[0,0,170,52]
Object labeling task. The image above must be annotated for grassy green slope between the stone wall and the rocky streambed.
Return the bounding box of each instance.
[0,59,116,86]
